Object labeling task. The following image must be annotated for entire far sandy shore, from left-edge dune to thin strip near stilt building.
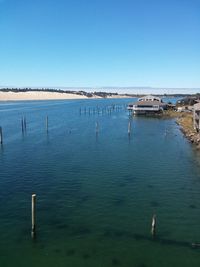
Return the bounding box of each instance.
[0,91,132,102]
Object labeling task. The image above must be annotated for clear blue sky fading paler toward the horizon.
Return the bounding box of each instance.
[0,0,200,91]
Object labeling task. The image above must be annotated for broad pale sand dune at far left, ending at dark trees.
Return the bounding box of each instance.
[0,91,88,101]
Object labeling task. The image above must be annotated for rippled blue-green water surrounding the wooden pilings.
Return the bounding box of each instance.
[0,99,200,267]
